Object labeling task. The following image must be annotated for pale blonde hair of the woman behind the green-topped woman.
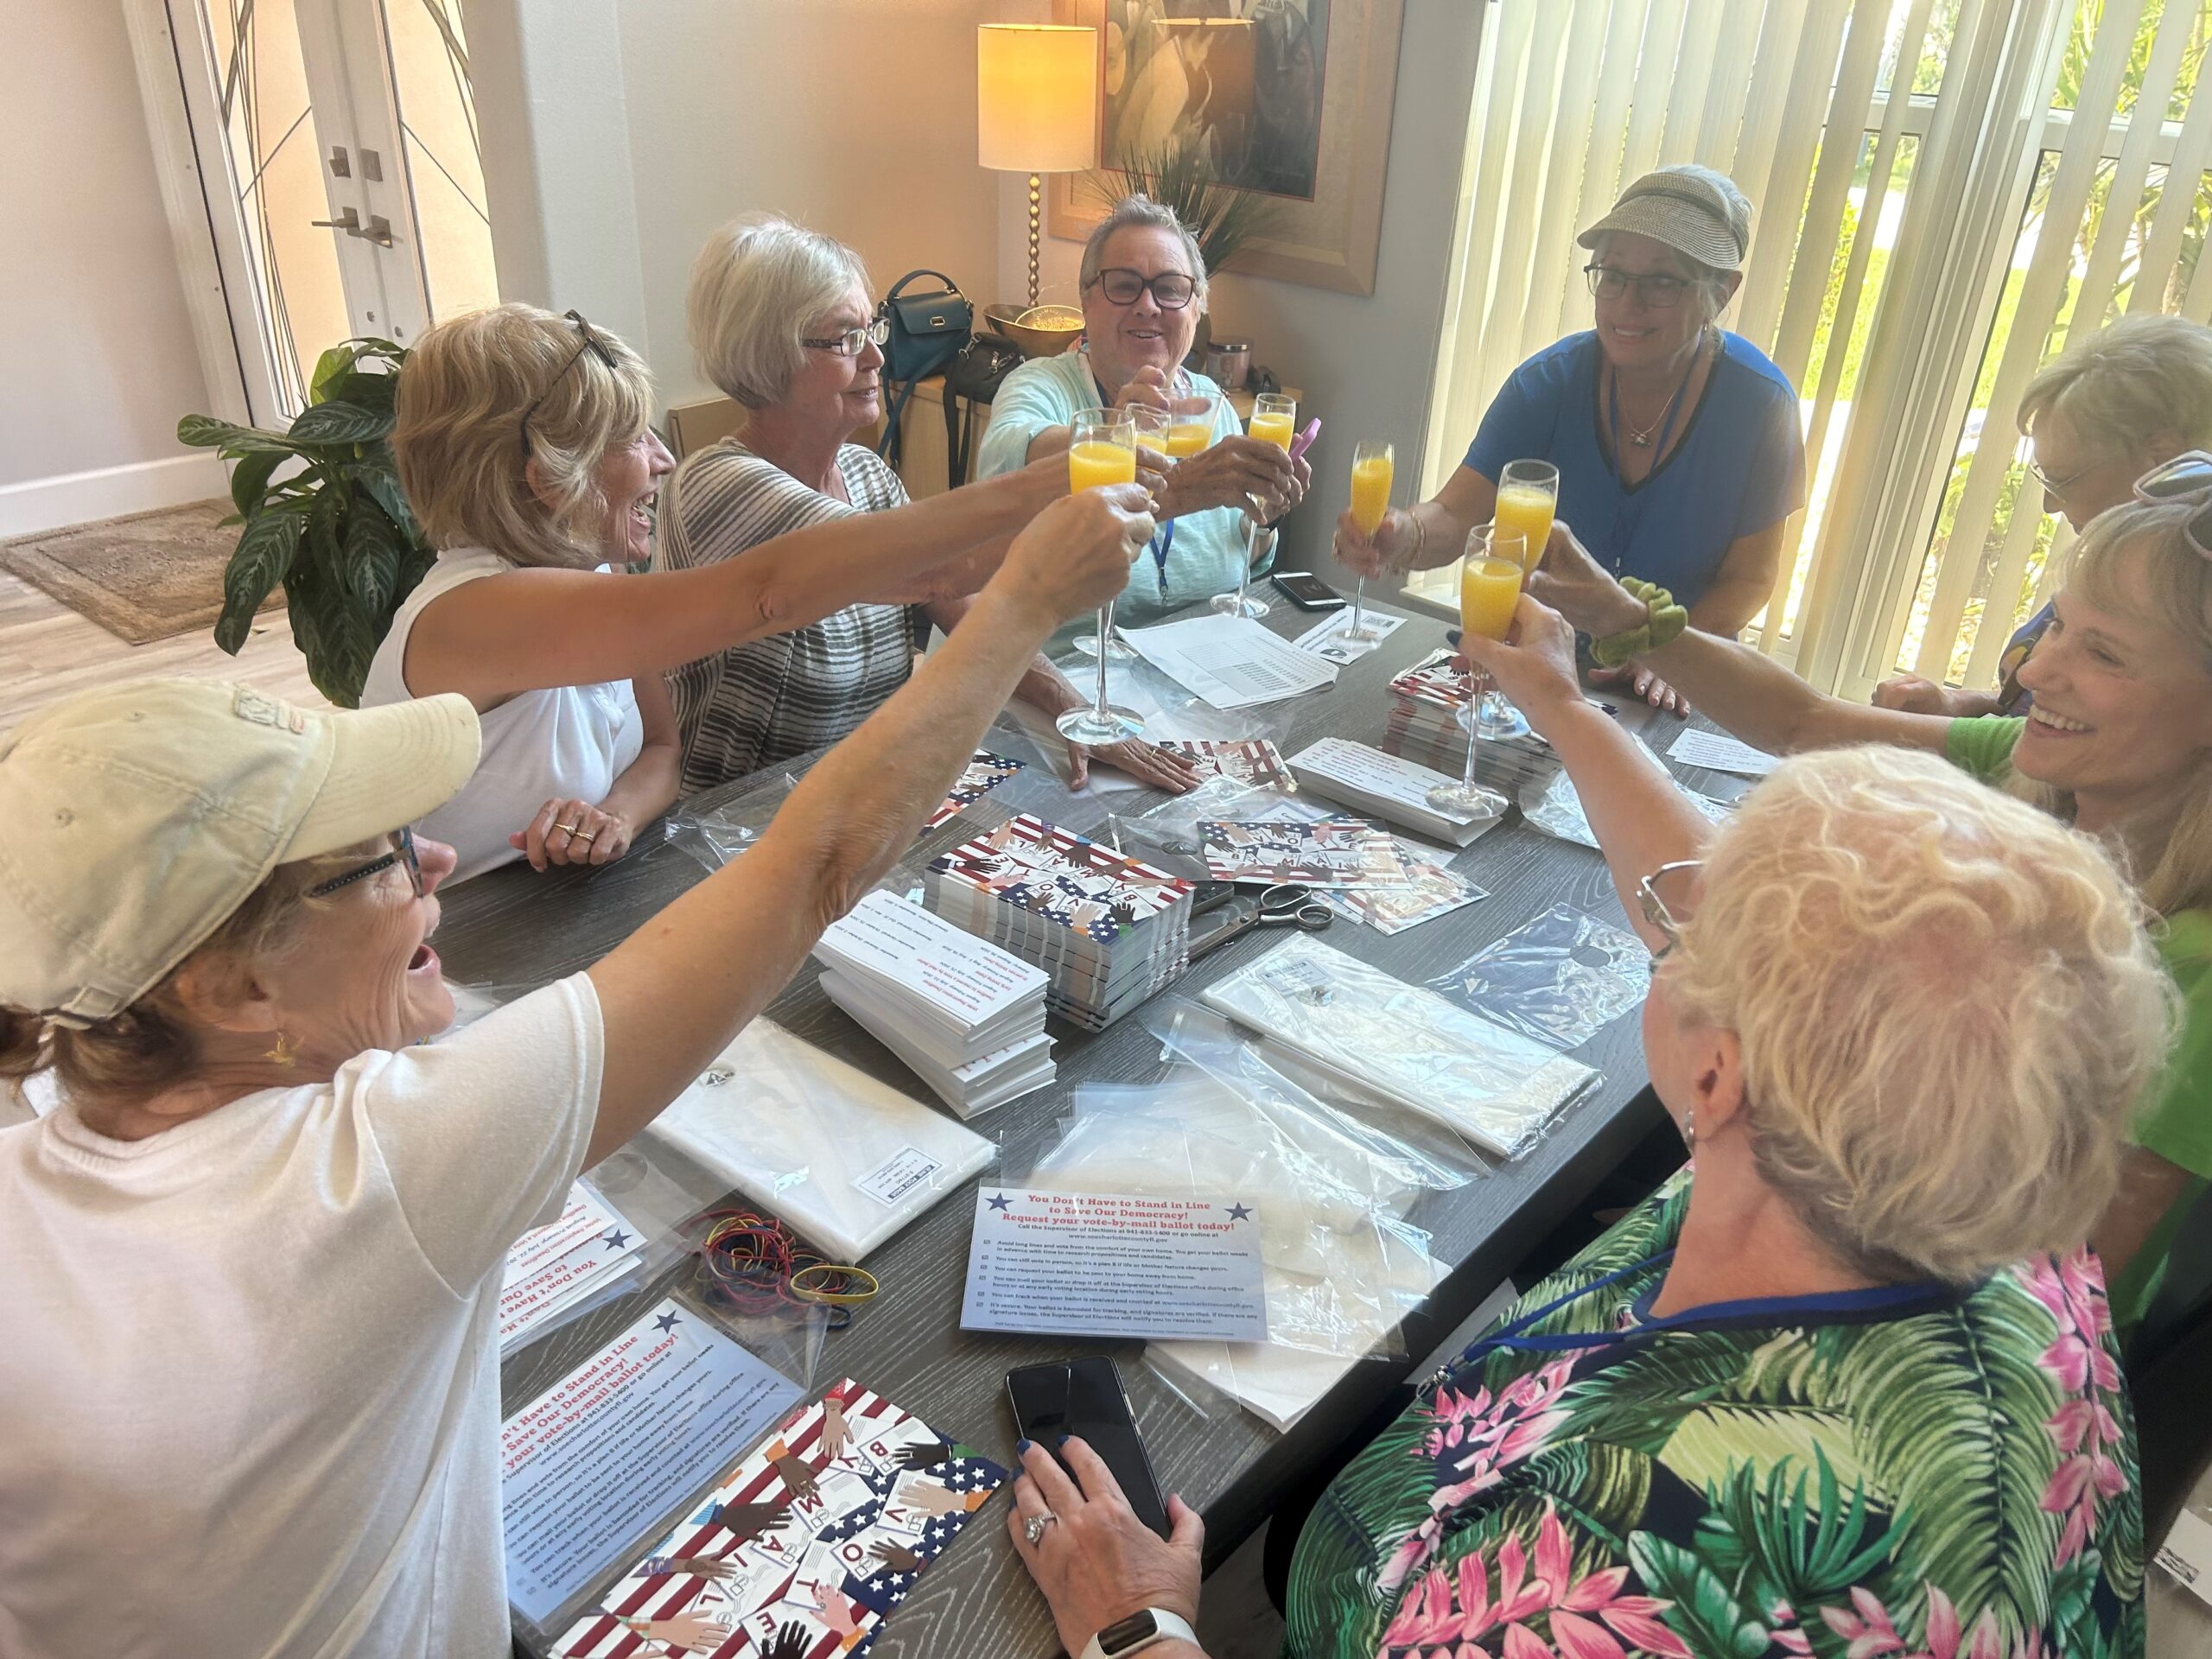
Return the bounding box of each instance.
[2019,316,2212,467]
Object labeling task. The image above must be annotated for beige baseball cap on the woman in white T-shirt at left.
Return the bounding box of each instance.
[0,679,478,1022]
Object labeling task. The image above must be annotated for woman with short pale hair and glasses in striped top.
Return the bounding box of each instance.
[655,214,1194,794]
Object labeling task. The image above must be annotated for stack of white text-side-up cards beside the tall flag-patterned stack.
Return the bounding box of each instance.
[814,892,1058,1117]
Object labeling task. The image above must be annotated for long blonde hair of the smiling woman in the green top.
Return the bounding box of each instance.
[2006,500,2212,916]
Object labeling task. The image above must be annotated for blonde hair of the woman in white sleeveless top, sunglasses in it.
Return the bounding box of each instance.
[391,305,652,566]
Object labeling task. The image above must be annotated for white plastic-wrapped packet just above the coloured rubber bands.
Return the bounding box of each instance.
[651,1020,998,1263]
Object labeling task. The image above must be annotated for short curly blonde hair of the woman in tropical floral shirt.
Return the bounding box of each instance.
[1659,746,2177,1283]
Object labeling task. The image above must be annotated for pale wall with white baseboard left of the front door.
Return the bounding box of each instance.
[0,0,224,536]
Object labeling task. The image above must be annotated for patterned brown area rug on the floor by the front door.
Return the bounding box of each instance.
[0,500,283,646]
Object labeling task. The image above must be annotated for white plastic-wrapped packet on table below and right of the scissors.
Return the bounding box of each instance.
[1199,936,1599,1157]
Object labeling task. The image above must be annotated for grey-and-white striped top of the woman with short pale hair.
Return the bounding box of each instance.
[652,438,929,794]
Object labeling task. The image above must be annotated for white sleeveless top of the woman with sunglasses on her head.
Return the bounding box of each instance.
[360,546,646,880]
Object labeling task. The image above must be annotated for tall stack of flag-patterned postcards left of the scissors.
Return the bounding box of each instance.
[923,814,1190,1031]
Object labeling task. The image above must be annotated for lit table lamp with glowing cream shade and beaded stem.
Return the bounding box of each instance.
[976,22,1099,308]
